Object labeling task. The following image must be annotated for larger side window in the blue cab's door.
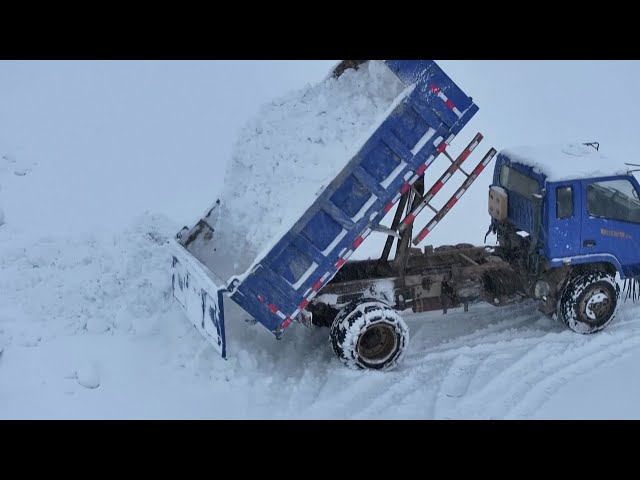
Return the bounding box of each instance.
[587,180,640,223]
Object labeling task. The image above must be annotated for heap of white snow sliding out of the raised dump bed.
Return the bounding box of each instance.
[210,61,409,279]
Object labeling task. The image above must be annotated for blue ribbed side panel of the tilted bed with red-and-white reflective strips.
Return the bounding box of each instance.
[232,60,478,333]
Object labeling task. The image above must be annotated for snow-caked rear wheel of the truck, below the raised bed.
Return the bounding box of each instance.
[330,299,409,371]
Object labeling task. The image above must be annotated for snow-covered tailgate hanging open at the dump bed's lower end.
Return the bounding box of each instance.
[171,241,227,359]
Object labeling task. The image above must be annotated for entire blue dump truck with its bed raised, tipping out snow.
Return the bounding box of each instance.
[172,60,640,370]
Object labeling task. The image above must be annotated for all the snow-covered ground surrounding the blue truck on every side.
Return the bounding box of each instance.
[0,61,640,418]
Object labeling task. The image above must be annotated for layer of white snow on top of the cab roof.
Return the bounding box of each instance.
[501,144,629,182]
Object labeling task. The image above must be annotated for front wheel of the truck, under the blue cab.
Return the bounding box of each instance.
[558,271,620,335]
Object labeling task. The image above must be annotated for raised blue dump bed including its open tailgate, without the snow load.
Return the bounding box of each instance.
[173,60,484,356]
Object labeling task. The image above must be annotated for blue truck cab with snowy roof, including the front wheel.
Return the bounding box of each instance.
[489,144,640,333]
